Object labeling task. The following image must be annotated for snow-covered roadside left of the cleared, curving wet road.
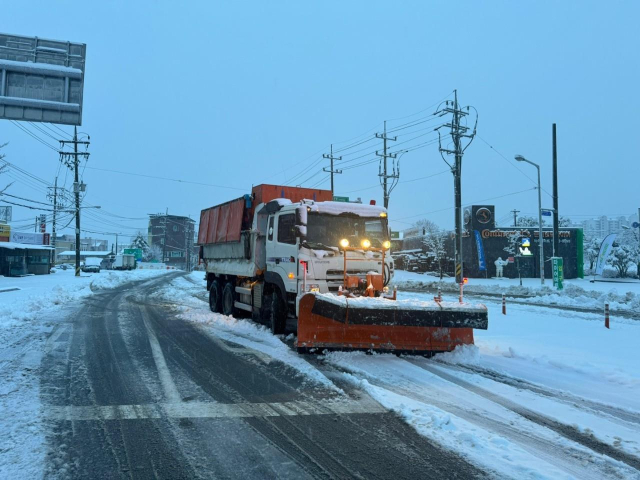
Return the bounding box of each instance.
[0,270,171,478]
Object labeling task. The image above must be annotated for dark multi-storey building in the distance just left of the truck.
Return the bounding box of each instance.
[147,214,195,270]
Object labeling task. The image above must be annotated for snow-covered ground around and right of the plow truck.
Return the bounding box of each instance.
[162,272,640,479]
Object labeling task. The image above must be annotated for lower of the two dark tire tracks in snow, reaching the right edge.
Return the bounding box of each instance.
[405,359,640,471]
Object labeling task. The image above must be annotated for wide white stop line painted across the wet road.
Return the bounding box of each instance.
[44,399,387,421]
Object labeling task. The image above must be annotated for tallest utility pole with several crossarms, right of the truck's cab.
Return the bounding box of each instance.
[435,90,478,288]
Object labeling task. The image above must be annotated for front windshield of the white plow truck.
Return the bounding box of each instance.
[307,213,388,248]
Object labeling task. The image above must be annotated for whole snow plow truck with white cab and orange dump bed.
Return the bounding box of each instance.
[198,185,488,354]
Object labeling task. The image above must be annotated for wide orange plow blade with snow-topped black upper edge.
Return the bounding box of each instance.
[297,293,488,354]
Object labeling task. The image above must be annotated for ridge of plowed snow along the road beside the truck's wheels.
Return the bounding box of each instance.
[157,272,341,392]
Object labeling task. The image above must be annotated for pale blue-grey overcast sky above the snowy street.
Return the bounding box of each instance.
[0,0,640,244]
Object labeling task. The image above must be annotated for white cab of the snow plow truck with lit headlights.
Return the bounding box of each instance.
[256,200,393,322]
